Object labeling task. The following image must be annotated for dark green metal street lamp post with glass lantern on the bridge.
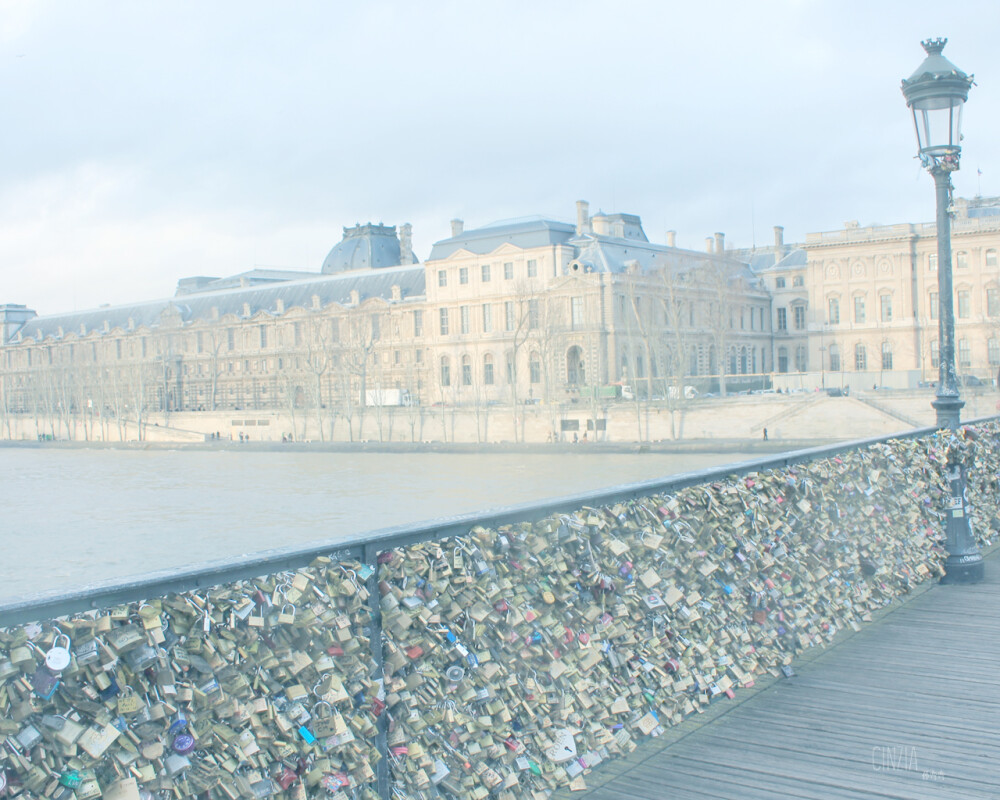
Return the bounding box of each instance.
[902,39,983,583]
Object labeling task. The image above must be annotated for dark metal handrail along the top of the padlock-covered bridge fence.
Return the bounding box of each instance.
[0,415,1000,628]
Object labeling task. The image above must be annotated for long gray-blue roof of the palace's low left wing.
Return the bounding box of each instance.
[13,264,424,339]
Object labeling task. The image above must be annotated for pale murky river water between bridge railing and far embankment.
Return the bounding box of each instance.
[0,448,746,600]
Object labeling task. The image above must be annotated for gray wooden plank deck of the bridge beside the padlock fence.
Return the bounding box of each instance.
[558,551,1000,800]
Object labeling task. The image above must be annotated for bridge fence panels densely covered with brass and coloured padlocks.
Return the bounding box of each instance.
[0,422,1000,800]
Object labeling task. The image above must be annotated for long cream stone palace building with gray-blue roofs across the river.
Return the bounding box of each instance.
[0,199,1000,440]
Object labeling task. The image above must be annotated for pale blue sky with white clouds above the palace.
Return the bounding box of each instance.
[0,0,1000,314]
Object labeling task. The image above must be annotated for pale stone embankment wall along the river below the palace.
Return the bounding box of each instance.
[7,390,998,443]
